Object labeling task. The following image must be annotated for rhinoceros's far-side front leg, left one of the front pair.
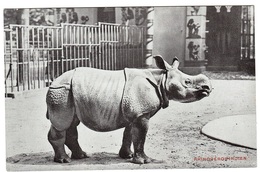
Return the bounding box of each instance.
[119,125,133,159]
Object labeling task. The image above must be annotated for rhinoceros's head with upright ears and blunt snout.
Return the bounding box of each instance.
[154,56,212,103]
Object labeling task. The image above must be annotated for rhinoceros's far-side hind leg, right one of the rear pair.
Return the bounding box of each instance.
[65,115,88,159]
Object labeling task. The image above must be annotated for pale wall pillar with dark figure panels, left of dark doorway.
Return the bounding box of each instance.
[183,6,207,74]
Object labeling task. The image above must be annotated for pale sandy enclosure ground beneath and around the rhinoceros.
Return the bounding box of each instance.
[5,80,256,170]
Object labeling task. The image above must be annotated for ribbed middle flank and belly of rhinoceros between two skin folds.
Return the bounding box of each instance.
[72,68,126,131]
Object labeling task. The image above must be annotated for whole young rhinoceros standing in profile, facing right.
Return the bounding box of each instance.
[46,56,212,164]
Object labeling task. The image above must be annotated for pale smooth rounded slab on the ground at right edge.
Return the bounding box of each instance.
[201,114,257,149]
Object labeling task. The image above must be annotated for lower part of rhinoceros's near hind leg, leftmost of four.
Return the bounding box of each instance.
[48,126,71,163]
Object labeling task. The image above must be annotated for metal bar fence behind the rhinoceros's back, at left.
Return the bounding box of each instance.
[4,23,146,95]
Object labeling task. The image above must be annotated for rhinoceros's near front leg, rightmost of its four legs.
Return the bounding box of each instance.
[131,116,151,164]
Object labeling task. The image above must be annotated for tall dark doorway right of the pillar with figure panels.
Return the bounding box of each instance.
[206,6,242,70]
